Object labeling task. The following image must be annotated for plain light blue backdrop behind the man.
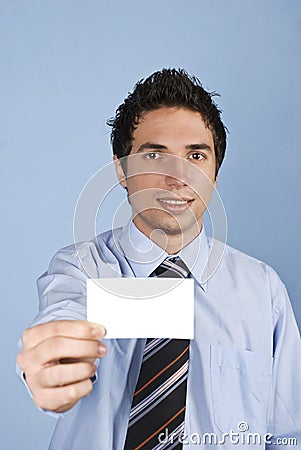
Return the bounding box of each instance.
[0,0,301,450]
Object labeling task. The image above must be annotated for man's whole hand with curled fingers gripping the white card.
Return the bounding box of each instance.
[17,320,107,412]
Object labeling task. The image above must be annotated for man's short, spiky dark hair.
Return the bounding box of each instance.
[107,69,226,175]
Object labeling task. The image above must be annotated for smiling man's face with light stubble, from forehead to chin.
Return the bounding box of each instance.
[118,107,216,243]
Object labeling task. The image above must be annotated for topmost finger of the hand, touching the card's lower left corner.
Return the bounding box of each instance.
[22,320,106,348]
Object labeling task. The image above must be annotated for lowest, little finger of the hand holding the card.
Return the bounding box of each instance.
[33,379,93,413]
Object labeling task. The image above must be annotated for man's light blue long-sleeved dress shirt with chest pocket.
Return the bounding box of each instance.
[17,223,301,450]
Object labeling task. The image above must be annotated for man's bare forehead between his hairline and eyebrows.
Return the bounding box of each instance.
[133,107,213,143]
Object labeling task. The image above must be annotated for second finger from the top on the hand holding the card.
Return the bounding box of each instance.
[26,336,107,366]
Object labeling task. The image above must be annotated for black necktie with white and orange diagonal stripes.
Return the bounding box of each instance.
[124,258,189,450]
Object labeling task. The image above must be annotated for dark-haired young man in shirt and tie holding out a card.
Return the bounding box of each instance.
[18,69,301,450]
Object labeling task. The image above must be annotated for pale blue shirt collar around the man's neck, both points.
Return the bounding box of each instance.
[120,221,209,291]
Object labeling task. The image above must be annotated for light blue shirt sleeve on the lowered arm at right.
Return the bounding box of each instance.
[266,271,301,449]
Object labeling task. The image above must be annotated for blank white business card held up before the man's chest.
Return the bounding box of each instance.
[87,278,194,339]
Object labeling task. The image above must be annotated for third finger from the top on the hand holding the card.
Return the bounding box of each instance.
[38,362,97,388]
